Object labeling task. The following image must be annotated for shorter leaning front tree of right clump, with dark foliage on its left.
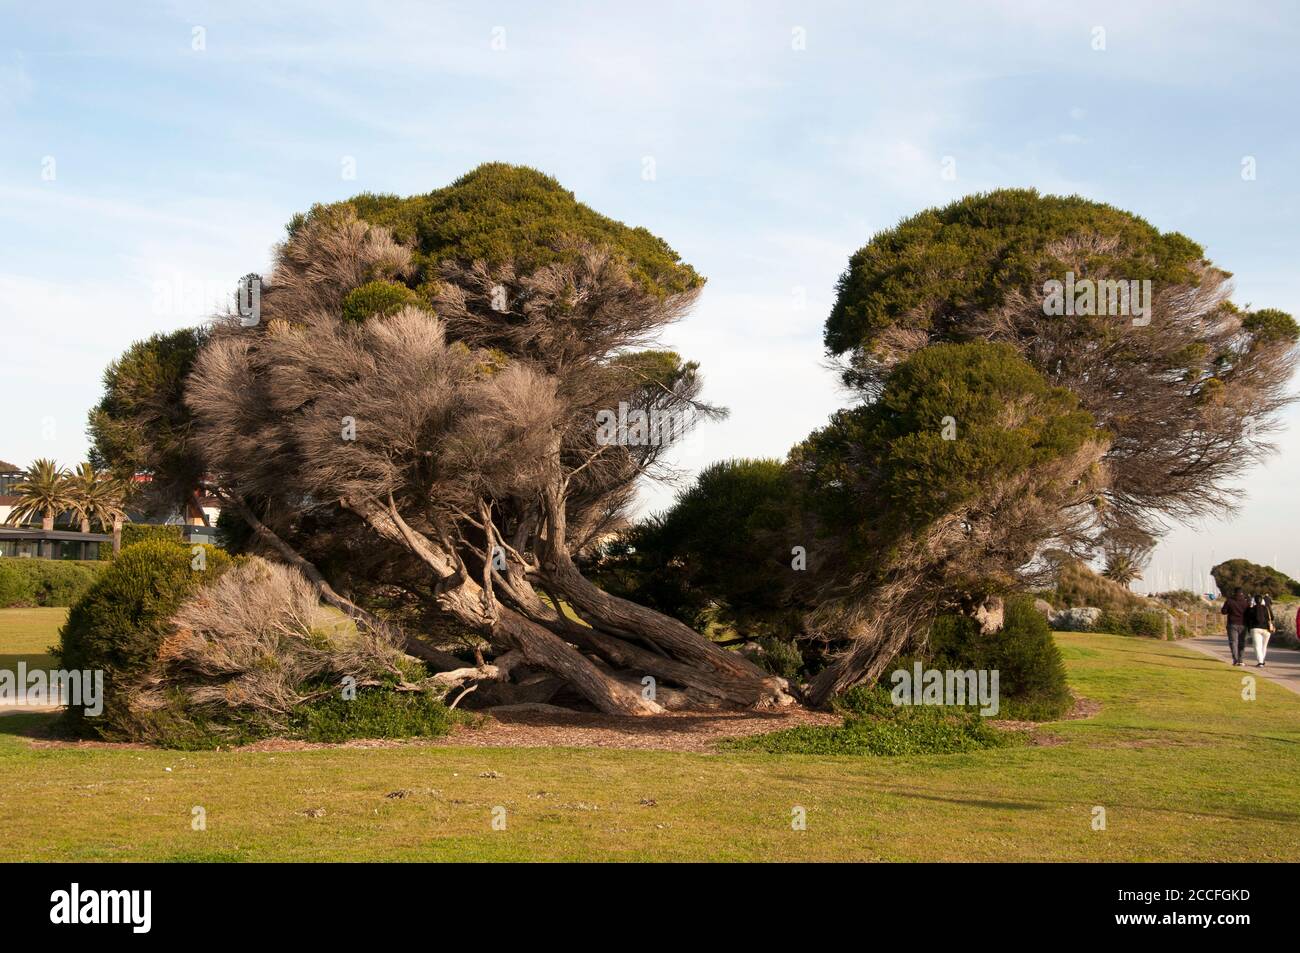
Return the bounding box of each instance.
[598,342,1109,703]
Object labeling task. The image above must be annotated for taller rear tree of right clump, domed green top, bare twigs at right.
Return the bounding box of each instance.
[800,190,1300,694]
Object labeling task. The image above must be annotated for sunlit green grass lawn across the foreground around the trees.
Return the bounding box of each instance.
[0,610,1300,861]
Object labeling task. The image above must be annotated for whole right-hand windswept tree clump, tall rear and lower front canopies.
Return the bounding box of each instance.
[599,190,1297,701]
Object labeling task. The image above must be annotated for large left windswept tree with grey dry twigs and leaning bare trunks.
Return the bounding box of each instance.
[131,165,789,714]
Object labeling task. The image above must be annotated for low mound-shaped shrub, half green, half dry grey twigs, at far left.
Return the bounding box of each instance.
[71,553,452,749]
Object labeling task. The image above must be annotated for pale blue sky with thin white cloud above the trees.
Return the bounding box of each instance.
[0,0,1300,590]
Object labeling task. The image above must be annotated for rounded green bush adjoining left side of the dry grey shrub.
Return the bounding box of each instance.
[57,542,231,733]
